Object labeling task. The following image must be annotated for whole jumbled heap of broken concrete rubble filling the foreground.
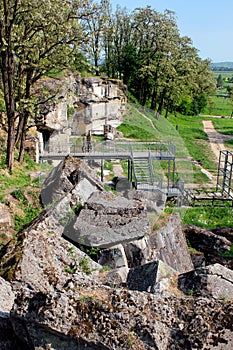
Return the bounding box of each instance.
[0,158,233,350]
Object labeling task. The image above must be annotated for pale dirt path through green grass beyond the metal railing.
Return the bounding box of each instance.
[202,120,232,159]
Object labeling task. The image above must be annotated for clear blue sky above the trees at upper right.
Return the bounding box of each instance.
[110,0,233,62]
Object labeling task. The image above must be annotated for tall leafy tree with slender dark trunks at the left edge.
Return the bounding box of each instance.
[0,0,87,170]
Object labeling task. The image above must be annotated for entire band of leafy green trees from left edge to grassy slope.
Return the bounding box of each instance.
[0,0,216,170]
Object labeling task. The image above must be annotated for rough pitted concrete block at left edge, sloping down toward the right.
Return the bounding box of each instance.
[0,228,101,293]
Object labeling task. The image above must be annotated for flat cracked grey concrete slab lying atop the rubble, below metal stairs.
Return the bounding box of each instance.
[65,192,150,248]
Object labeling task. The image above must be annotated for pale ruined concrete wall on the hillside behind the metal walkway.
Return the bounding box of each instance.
[36,75,126,153]
